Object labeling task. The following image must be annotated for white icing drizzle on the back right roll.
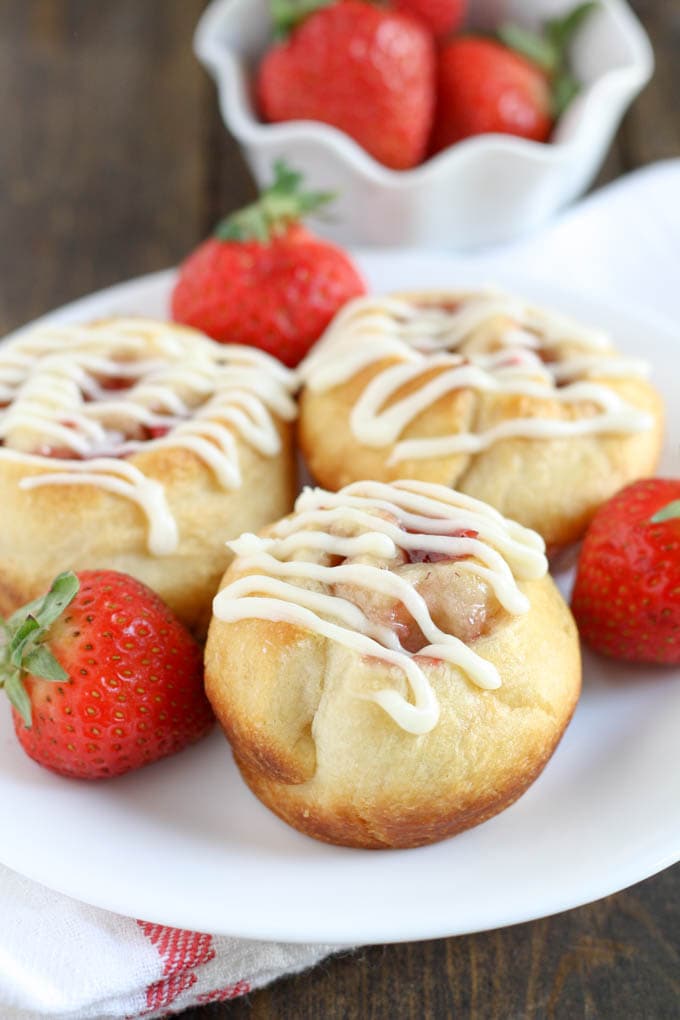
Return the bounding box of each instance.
[300,292,653,463]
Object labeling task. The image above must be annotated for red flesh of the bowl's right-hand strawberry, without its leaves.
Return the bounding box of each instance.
[432,36,553,152]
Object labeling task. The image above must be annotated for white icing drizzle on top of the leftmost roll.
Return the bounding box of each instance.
[0,318,296,556]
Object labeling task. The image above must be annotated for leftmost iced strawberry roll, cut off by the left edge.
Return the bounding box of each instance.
[0,318,296,631]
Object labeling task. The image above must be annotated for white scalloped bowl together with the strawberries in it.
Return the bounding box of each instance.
[195,0,653,249]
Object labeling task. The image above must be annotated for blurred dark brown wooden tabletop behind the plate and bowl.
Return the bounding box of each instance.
[0,0,680,333]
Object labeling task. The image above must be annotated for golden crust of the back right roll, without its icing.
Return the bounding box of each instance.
[298,292,664,549]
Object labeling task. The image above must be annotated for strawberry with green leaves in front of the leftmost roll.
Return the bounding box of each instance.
[0,570,213,779]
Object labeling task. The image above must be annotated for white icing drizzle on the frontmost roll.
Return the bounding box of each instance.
[213,481,547,733]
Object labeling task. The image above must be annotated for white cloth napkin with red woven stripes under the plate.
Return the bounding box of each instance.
[0,160,680,1020]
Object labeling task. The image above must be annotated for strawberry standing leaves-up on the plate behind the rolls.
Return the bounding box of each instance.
[172,162,366,367]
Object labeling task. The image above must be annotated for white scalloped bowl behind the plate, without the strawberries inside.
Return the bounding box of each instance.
[194,0,653,249]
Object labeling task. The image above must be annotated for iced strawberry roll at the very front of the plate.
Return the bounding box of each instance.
[206,481,580,848]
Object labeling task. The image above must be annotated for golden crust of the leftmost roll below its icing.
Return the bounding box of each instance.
[0,422,297,633]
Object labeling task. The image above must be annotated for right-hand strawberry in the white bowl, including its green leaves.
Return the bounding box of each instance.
[430,2,596,152]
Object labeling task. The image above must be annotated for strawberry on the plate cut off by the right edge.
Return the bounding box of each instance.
[572,478,680,664]
